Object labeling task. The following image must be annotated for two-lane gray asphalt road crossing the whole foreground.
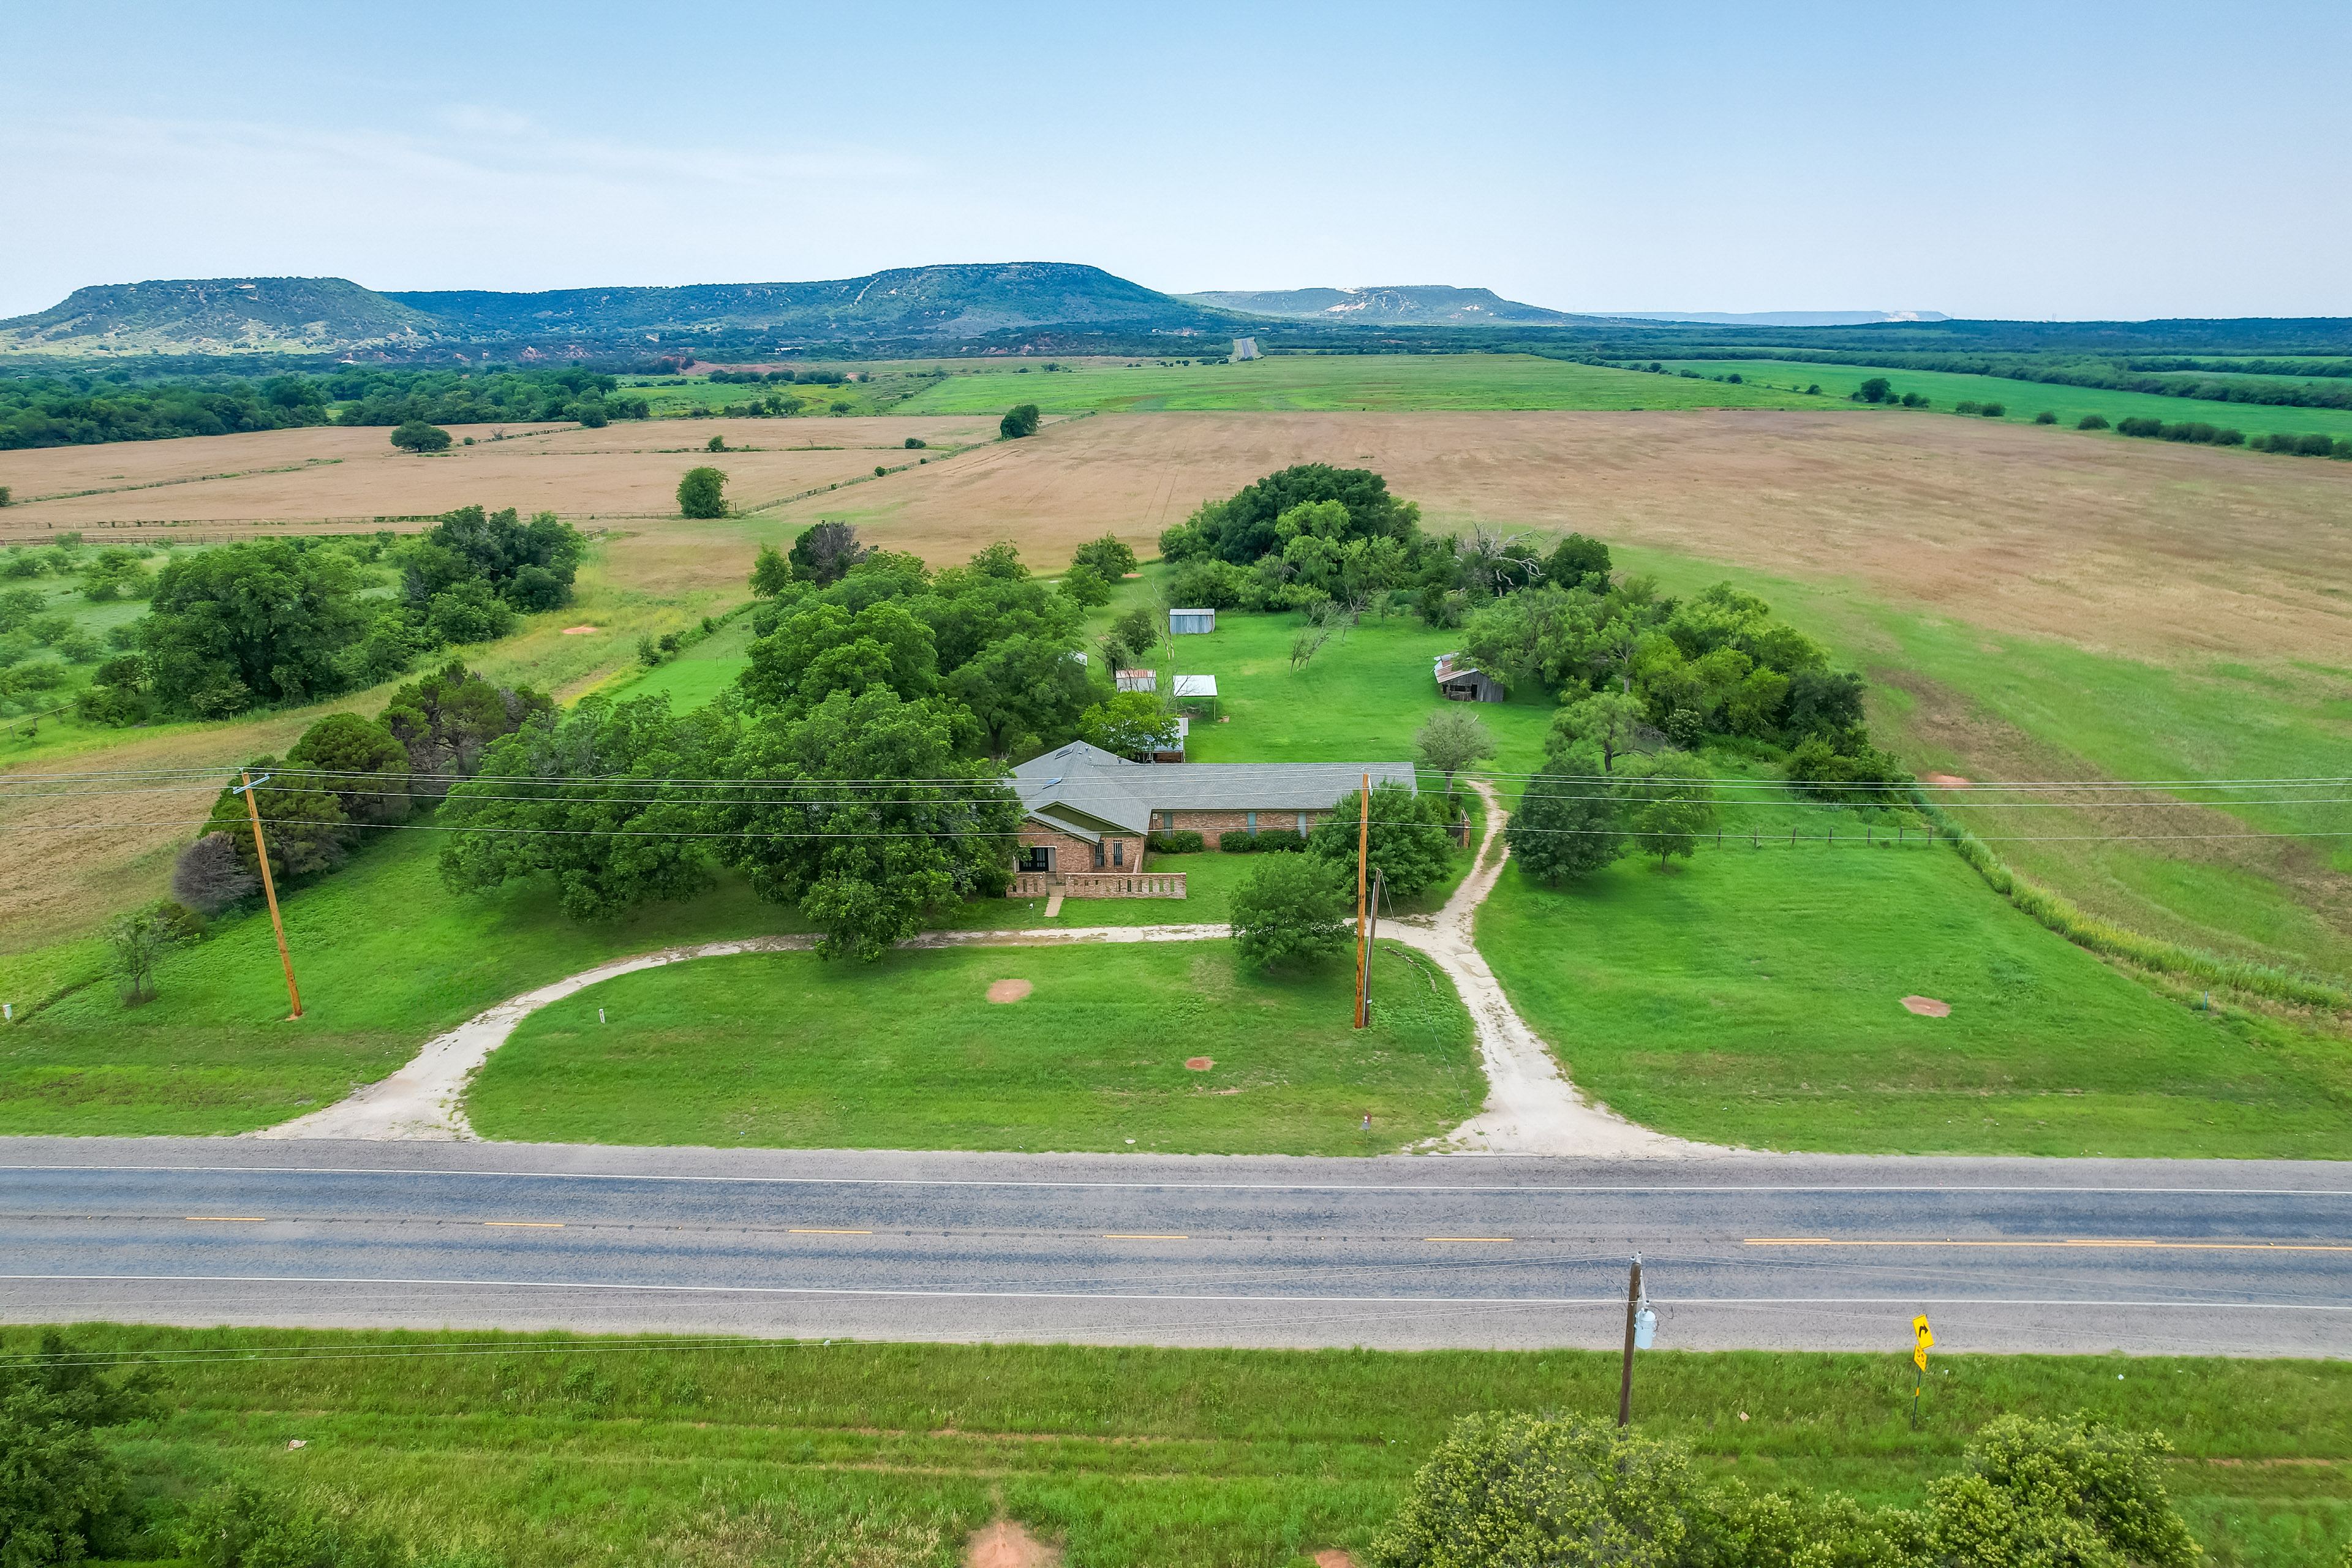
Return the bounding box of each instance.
[0,1138,2352,1354]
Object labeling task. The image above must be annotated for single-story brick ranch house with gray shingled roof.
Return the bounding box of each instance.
[1011,741,1416,898]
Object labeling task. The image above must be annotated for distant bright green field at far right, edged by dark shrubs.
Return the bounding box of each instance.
[1651,360,2352,442]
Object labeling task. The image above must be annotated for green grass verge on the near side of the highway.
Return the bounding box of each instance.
[41,1326,2352,1568]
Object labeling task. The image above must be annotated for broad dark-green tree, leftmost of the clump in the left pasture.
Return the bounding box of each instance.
[139,538,369,717]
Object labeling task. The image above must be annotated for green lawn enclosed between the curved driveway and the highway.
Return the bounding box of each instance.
[466,940,1487,1154]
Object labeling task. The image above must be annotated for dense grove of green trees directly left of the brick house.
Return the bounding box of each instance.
[440,524,1152,959]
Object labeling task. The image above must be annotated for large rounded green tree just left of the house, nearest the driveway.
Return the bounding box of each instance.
[708,687,1021,959]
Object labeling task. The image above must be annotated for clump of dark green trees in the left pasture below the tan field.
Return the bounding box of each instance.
[75,505,588,724]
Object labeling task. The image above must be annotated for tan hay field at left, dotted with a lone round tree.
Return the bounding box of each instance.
[0,416,995,538]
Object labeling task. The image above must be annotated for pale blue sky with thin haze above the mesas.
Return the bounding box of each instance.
[0,0,2352,320]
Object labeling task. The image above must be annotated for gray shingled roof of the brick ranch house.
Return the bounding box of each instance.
[1011,741,1414,839]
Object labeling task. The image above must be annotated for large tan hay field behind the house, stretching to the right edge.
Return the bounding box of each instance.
[781,409,2352,661]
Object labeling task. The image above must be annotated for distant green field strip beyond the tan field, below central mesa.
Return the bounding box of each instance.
[891,355,1825,413]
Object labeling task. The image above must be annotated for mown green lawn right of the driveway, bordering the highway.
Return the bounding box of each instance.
[1479,780,2352,1159]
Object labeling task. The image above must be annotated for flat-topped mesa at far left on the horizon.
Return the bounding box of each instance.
[0,277,459,360]
